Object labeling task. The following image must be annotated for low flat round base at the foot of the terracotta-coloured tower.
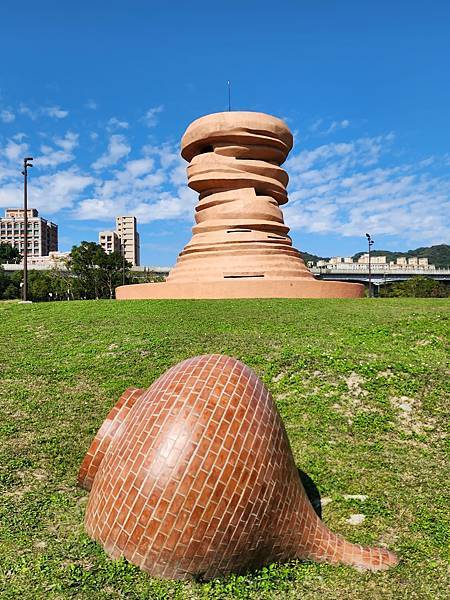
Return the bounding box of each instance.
[116,278,364,300]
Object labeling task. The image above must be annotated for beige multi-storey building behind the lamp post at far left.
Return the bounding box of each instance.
[0,208,58,259]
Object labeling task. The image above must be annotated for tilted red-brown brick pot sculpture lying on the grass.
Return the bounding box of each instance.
[79,355,397,579]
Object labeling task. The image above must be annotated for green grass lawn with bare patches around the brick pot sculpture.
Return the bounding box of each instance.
[0,299,450,600]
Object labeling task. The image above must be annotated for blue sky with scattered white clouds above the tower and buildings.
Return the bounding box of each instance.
[0,0,450,265]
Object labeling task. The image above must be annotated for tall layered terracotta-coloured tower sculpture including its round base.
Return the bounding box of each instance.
[116,112,364,299]
